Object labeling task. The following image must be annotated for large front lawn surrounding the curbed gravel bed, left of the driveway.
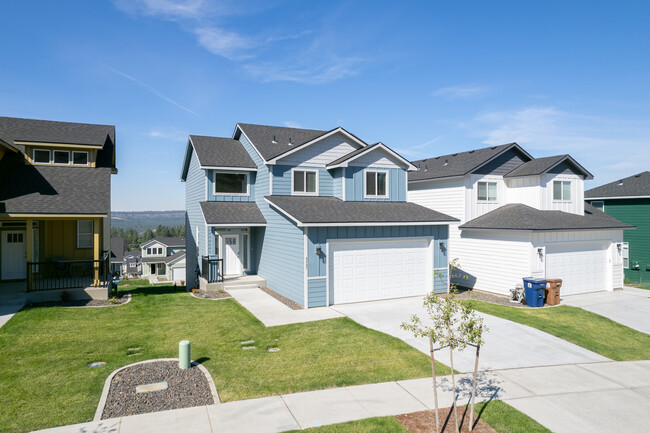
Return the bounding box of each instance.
[0,283,449,432]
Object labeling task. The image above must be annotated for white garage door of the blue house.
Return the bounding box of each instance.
[329,239,433,304]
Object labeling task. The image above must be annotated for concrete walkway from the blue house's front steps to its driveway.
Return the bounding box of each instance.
[226,288,345,326]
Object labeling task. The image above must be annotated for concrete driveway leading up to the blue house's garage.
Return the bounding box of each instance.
[331,296,608,372]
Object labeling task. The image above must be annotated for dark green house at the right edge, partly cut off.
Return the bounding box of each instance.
[585,171,650,285]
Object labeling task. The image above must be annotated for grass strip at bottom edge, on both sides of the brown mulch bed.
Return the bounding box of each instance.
[289,400,550,433]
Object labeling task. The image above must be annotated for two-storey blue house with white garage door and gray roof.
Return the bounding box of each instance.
[181,123,455,308]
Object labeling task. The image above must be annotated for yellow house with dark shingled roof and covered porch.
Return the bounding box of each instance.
[0,117,117,291]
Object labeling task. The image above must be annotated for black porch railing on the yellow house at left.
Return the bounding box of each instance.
[27,251,111,292]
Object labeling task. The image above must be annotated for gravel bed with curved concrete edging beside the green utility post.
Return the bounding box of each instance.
[101,361,215,419]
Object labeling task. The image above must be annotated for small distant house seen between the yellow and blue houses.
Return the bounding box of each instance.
[140,237,185,281]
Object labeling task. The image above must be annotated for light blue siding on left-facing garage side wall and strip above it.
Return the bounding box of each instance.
[239,134,305,305]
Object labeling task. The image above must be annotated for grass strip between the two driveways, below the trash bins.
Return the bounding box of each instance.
[469,301,650,361]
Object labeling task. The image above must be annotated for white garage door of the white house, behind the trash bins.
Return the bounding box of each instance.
[546,243,609,295]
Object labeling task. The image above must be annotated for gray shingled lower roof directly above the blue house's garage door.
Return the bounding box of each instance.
[265,195,458,225]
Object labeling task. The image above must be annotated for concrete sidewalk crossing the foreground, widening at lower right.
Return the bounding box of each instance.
[31,361,650,433]
